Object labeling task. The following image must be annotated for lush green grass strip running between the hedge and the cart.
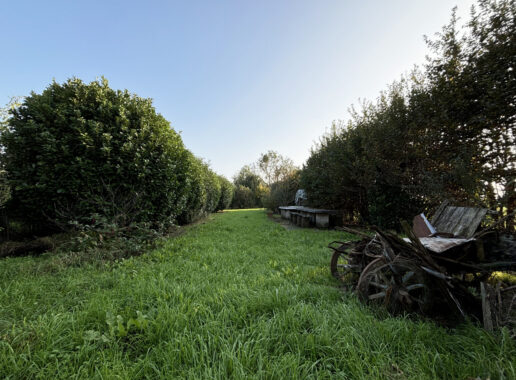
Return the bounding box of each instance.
[0,210,516,379]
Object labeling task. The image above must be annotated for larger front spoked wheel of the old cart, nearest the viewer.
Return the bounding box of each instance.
[357,258,432,314]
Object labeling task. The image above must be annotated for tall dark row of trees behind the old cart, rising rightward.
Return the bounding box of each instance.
[301,0,516,229]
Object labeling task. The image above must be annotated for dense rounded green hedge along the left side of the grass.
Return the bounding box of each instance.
[0,79,233,238]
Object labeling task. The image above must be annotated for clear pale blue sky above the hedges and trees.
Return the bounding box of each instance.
[0,0,473,178]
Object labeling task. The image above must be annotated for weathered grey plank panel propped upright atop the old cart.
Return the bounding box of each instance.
[432,206,487,239]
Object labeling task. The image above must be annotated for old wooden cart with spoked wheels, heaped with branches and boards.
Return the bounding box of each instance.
[329,204,516,329]
